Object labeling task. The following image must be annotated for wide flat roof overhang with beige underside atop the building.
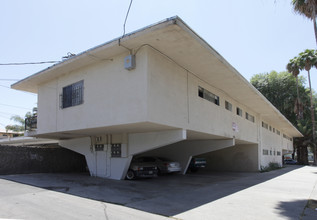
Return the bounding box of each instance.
[12,17,302,137]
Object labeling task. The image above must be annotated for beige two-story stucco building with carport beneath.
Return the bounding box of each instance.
[12,17,301,179]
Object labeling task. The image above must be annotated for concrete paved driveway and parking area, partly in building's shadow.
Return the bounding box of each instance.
[0,166,317,219]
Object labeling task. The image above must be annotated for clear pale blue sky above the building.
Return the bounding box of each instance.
[0,0,317,128]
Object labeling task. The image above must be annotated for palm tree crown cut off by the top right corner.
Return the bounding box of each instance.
[292,0,317,44]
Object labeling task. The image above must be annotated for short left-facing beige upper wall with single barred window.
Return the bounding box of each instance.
[38,51,147,134]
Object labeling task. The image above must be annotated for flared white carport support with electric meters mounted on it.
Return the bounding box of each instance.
[59,129,186,180]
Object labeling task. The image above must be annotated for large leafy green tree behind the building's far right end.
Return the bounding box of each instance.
[251,71,317,164]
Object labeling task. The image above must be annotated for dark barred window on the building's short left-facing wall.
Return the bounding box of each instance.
[61,80,84,108]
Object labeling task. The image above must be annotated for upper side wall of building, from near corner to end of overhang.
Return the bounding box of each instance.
[144,48,258,143]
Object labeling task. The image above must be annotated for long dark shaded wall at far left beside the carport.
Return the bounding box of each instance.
[0,146,87,175]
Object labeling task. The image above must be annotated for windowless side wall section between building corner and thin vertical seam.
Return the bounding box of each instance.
[144,48,188,128]
